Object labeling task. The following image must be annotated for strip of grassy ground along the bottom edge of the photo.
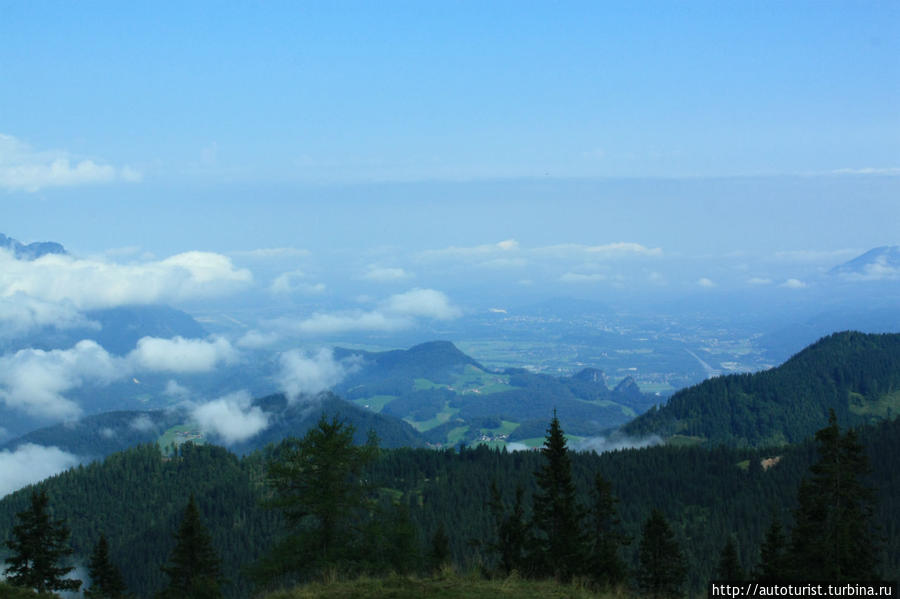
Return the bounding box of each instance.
[261,575,628,599]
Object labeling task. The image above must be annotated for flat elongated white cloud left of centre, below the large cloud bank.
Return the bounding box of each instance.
[128,337,238,372]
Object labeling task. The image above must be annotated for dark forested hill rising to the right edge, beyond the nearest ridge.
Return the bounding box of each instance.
[624,332,900,446]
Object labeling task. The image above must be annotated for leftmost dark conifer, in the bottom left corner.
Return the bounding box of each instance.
[4,491,81,592]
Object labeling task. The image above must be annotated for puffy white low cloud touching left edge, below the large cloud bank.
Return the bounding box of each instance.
[0,340,128,419]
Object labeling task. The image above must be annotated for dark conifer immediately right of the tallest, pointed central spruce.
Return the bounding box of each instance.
[588,474,630,587]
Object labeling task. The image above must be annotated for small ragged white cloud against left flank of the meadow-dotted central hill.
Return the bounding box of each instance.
[278,348,359,401]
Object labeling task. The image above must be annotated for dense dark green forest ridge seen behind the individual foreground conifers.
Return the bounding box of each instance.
[0,414,900,597]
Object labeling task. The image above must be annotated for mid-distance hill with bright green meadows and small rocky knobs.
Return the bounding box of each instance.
[334,341,657,445]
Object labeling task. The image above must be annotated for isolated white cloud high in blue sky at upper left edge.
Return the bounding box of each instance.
[0,134,142,192]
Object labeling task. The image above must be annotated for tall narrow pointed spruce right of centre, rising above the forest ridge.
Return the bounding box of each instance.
[532,410,585,582]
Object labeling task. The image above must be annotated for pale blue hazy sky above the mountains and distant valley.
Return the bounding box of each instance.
[0,1,900,290]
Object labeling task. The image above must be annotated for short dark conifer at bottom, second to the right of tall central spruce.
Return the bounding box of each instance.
[637,509,687,598]
